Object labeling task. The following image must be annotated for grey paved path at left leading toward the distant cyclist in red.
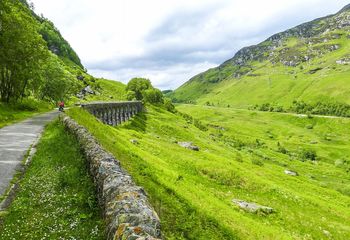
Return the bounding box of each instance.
[0,111,58,196]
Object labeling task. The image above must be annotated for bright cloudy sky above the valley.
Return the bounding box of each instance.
[29,0,350,90]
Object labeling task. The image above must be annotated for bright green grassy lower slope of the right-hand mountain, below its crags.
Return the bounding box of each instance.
[171,27,350,107]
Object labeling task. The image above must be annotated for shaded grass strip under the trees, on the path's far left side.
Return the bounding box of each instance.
[0,99,52,128]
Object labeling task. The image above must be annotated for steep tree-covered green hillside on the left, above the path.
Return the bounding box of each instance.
[0,0,126,105]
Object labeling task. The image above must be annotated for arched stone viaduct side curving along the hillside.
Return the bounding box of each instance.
[81,101,143,126]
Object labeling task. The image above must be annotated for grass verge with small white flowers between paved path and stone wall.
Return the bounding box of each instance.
[0,121,104,240]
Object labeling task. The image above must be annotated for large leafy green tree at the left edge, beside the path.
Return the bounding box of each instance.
[0,0,48,102]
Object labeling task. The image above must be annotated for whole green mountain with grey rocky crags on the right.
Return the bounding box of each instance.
[169,5,350,107]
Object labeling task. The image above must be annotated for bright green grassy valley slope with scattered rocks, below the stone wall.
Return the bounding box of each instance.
[69,106,350,239]
